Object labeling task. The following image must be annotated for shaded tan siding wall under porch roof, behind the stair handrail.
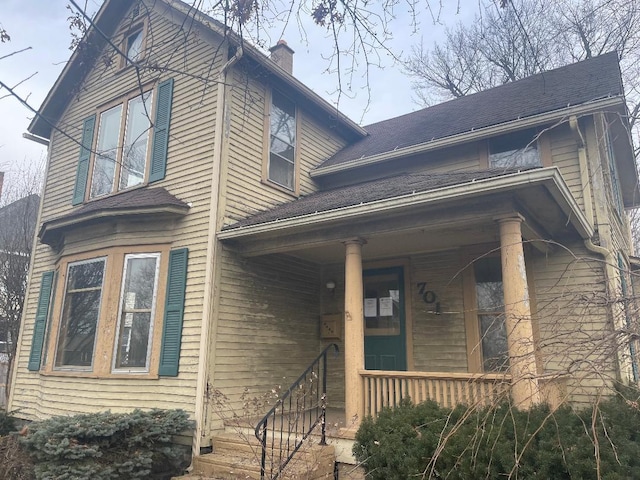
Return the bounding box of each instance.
[208,247,320,434]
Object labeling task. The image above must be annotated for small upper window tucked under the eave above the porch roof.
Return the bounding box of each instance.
[489,130,542,168]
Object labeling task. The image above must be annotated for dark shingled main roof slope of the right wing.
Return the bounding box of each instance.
[318,52,623,168]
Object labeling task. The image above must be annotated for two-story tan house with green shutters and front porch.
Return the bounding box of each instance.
[9,0,639,474]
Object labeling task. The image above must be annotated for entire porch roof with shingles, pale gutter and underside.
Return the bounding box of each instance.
[218,167,593,260]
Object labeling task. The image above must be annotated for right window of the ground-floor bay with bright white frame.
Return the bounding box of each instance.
[112,253,160,372]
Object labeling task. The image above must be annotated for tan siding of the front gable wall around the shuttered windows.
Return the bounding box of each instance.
[12,2,225,418]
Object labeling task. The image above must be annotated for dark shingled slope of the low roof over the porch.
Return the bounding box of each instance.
[223,169,517,231]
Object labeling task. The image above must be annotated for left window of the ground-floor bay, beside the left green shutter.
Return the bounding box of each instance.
[55,257,107,370]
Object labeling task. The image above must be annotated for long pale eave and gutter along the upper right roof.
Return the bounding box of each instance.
[310,95,624,178]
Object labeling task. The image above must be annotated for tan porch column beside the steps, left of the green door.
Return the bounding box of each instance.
[344,238,366,429]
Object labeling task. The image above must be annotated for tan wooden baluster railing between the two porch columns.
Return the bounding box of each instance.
[360,370,511,416]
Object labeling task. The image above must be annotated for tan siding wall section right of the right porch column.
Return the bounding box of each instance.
[531,244,616,403]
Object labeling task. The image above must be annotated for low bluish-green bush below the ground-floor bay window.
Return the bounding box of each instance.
[22,410,193,480]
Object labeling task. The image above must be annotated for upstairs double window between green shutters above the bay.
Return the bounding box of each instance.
[89,91,153,198]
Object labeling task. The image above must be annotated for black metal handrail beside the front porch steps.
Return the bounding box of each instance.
[255,343,340,480]
